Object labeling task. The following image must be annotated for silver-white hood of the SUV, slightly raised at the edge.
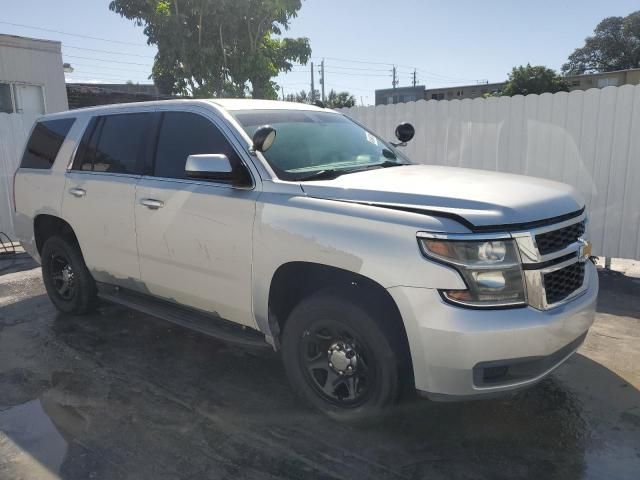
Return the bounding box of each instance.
[301,165,584,231]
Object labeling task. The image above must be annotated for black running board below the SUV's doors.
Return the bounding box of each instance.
[98,283,271,348]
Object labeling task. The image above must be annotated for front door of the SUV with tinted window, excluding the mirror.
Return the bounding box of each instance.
[135,111,258,327]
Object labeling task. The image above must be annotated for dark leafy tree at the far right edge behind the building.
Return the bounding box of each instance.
[562,10,640,75]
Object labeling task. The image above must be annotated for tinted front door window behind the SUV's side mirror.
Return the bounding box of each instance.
[154,112,240,178]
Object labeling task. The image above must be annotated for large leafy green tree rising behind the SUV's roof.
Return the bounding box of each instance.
[109,0,311,98]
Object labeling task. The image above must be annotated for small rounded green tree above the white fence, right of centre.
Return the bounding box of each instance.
[500,63,569,96]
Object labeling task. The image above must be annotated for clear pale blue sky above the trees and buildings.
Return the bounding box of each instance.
[0,0,640,105]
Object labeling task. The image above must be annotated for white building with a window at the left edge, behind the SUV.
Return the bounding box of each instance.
[0,34,68,237]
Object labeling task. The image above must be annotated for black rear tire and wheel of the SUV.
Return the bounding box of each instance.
[41,236,97,315]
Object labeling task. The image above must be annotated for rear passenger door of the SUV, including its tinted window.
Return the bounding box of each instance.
[62,111,153,289]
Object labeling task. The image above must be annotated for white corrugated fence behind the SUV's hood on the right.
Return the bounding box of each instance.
[343,85,640,259]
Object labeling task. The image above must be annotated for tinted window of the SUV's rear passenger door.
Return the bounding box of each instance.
[74,113,151,174]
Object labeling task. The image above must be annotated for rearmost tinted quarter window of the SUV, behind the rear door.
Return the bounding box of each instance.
[20,118,75,169]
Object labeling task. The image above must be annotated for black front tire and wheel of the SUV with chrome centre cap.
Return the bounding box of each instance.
[282,291,402,422]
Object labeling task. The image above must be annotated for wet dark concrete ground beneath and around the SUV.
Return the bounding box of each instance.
[0,258,640,480]
